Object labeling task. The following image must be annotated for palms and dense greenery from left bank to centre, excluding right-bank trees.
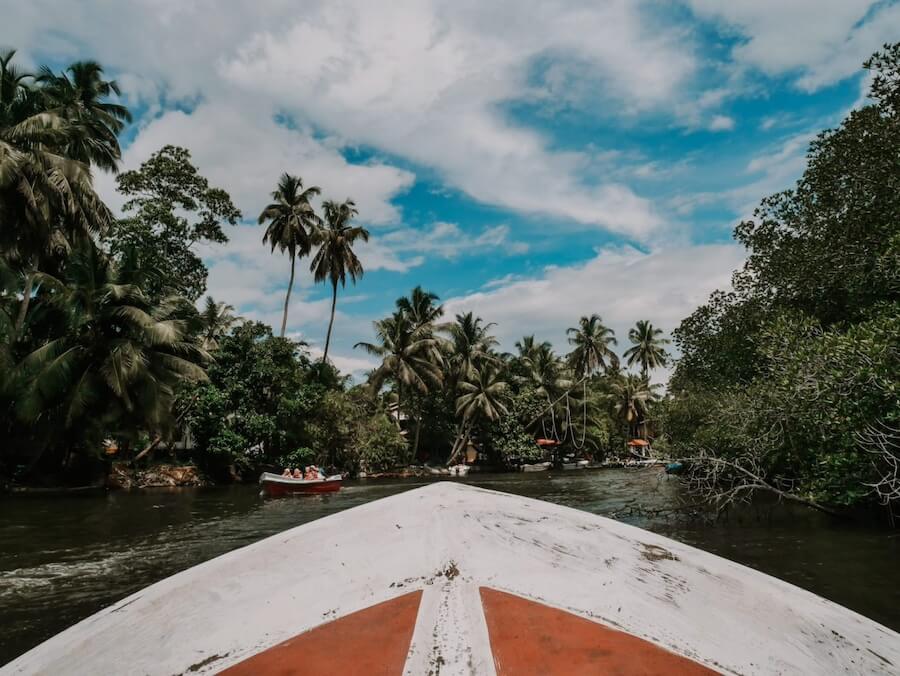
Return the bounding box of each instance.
[0,52,666,482]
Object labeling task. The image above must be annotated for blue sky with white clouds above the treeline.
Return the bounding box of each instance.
[0,0,900,378]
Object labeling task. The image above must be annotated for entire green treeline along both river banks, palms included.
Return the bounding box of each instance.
[0,45,900,506]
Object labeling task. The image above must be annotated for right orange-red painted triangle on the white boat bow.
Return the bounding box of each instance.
[480,587,717,676]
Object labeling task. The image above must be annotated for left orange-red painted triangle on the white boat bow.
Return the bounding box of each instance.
[221,591,422,676]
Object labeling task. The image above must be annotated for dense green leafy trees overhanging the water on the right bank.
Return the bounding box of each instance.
[664,45,900,520]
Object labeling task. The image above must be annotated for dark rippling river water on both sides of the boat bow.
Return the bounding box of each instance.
[0,469,900,664]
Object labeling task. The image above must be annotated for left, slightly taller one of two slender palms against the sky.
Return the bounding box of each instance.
[259,173,322,338]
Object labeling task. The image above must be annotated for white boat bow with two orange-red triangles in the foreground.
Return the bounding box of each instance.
[0,481,900,676]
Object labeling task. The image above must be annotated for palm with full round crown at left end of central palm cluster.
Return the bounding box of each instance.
[353,310,442,426]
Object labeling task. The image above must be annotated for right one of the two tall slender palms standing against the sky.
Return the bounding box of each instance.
[310,199,369,362]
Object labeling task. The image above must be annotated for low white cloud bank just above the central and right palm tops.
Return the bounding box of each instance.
[445,244,744,372]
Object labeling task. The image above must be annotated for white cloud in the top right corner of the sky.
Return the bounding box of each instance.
[687,0,900,91]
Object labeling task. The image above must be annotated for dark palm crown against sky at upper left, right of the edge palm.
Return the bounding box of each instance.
[37,61,131,171]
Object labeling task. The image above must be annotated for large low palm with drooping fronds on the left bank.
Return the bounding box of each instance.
[17,241,209,462]
